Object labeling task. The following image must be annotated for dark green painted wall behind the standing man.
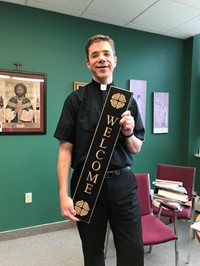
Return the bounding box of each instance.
[0,2,200,231]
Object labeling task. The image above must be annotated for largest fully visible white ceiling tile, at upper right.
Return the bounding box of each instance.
[133,0,200,30]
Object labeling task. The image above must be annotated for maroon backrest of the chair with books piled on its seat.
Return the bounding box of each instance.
[156,164,196,199]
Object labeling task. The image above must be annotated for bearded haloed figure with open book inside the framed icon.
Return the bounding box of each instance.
[5,83,34,123]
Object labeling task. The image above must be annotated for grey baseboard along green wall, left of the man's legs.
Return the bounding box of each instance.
[0,220,76,242]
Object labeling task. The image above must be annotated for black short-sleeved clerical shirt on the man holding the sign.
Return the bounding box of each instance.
[54,80,144,170]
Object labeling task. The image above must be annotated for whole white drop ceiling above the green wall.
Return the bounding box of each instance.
[0,0,200,39]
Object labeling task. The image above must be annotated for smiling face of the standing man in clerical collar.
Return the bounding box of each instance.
[86,41,117,84]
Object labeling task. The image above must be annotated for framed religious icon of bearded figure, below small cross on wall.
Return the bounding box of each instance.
[0,70,46,134]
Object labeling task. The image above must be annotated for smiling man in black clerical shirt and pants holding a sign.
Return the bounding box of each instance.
[54,35,144,266]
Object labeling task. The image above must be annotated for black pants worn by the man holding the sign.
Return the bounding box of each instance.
[72,171,144,266]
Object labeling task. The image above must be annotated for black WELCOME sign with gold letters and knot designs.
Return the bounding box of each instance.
[73,86,132,223]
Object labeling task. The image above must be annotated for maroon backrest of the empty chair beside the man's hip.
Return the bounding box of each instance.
[135,173,152,216]
